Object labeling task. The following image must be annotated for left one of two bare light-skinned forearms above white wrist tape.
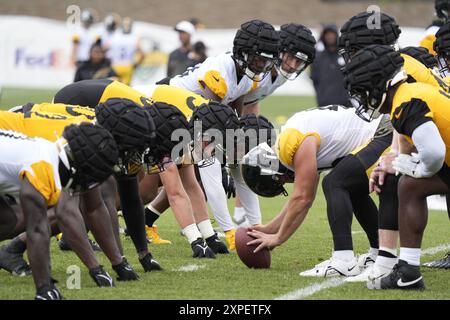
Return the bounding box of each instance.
[159,163,193,228]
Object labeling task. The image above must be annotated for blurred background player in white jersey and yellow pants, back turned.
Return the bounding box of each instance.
[108,17,144,85]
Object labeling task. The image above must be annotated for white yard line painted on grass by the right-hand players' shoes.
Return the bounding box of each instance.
[274,243,450,300]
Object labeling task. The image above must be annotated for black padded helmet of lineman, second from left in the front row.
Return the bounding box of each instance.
[95,98,156,175]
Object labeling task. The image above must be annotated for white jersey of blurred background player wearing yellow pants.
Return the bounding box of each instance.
[108,32,138,65]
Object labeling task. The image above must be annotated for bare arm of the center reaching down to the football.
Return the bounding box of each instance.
[277,136,318,244]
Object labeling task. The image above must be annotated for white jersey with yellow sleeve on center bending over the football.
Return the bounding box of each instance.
[275,105,382,170]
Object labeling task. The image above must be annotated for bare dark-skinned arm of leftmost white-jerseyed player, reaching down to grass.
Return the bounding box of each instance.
[20,177,50,289]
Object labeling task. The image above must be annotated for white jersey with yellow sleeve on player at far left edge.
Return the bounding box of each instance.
[0,130,61,205]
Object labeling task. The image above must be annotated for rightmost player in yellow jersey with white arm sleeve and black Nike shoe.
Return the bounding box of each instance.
[344,45,450,289]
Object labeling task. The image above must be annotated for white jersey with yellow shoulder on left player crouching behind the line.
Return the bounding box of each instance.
[170,53,257,104]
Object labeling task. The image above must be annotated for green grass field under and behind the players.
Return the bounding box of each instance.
[0,89,450,300]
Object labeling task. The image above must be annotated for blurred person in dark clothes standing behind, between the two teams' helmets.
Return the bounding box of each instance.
[311,24,349,106]
